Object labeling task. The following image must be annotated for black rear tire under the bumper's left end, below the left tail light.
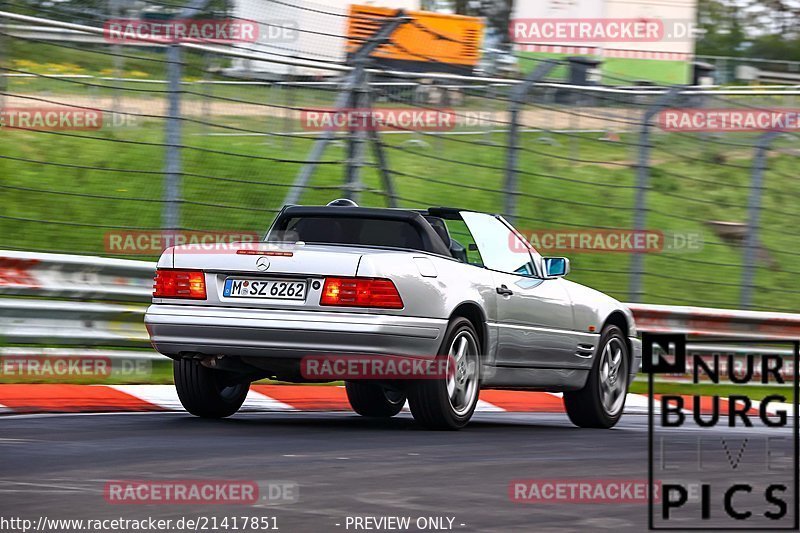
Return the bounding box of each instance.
[172,359,250,418]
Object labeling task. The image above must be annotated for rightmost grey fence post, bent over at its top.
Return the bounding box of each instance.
[740,131,781,309]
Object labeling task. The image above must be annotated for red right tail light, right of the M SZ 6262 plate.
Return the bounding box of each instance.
[319,278,403,309]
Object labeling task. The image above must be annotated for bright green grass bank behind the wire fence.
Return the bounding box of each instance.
[0,116,800,311]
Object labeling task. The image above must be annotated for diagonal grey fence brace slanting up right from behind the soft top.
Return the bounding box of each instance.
[283,9,411,205]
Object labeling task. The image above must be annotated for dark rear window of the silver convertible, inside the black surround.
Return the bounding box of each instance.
[267,216,424,250]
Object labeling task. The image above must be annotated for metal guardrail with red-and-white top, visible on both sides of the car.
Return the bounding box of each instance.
[0,250,800,364]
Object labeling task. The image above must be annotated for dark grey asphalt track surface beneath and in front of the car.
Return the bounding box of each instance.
[0,413,794,532]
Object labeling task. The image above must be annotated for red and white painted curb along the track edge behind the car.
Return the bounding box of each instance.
[0,384,792,414]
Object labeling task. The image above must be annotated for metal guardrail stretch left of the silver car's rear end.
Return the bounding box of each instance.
[0,250,155,350]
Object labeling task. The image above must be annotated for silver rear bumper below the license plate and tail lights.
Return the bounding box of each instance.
[144,304,447,357]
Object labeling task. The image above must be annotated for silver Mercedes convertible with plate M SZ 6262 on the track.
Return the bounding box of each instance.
[145,201,641,429]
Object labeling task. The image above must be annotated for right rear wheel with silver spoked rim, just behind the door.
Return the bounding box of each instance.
[408,317,481,430]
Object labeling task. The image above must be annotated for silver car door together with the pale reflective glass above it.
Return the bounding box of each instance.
[462,212,578,368]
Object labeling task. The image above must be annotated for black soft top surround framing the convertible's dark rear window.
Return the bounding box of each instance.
[267,206,451,257]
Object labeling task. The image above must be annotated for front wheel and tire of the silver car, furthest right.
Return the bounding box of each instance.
[564,326,630,429]
